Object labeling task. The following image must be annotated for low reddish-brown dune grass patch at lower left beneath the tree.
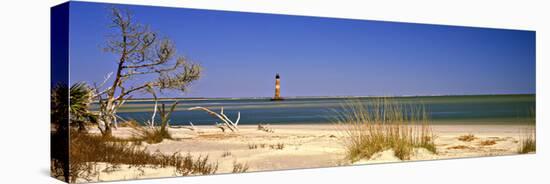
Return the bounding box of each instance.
[69,132,218,183]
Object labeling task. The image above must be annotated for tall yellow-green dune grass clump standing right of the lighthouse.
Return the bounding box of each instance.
[336,98,437,162]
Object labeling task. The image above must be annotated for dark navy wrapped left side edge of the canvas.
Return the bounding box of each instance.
[50,2,69,182]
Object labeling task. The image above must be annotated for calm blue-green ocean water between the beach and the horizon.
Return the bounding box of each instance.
[101,95,535,125]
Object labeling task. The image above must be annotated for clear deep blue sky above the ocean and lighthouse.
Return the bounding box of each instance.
[70,2,535,97]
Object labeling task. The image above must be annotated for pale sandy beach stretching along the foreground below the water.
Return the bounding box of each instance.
[85,124,529,181]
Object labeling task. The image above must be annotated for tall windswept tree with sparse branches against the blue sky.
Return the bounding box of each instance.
[94,8,201,136]
